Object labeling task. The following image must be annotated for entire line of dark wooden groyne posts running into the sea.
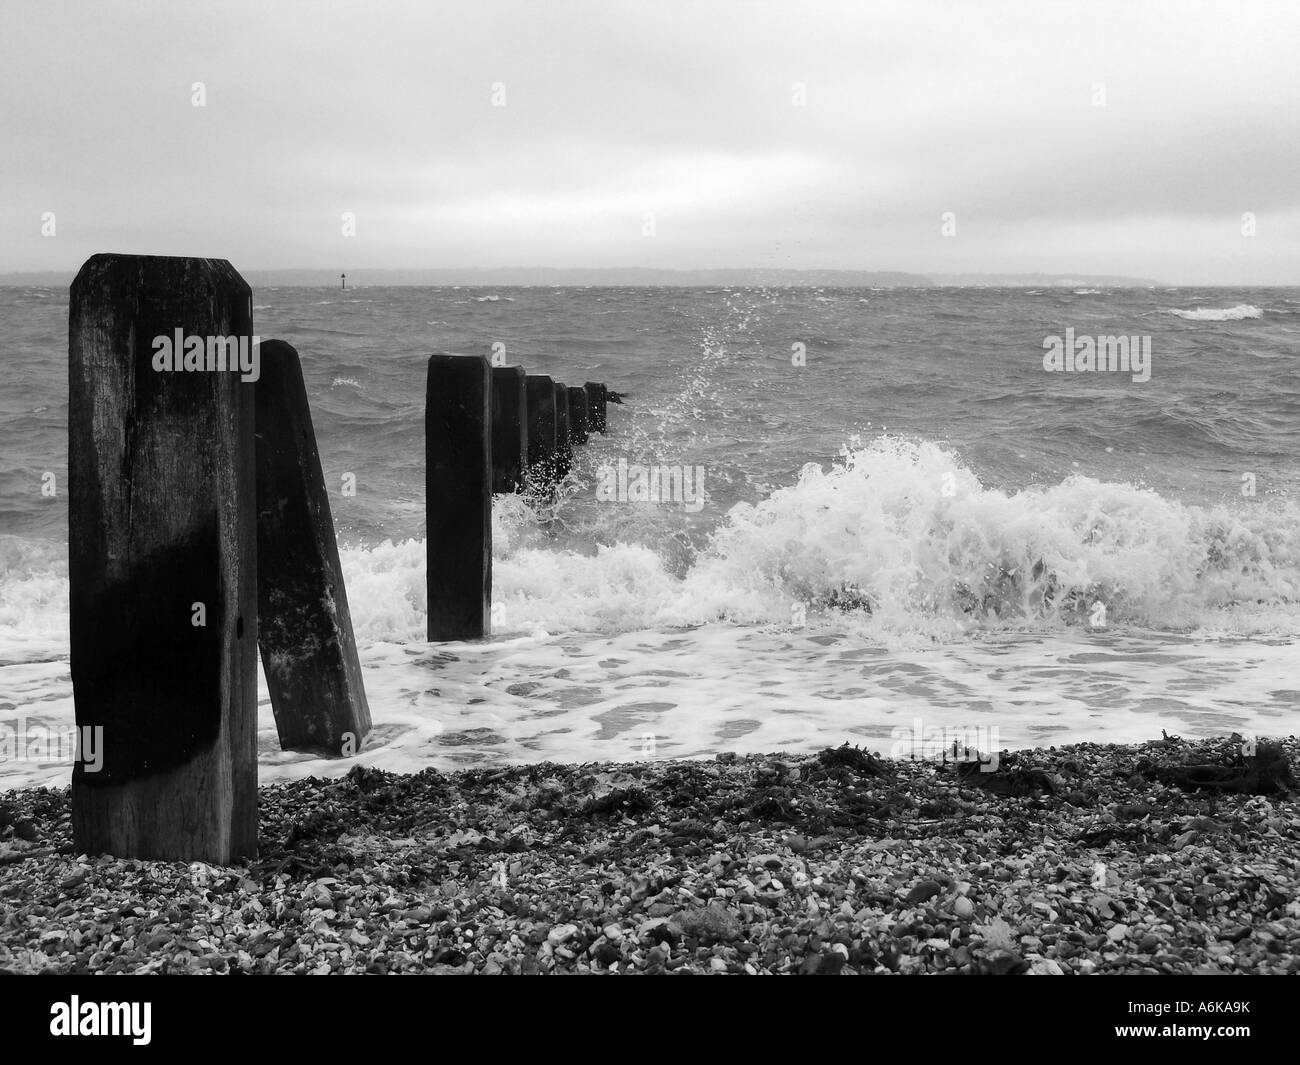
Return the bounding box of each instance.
[68,255,610,863]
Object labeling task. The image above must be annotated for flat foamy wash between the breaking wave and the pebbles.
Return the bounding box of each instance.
[0,624,1300,788]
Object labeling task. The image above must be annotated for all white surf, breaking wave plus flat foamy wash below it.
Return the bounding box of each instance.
[0,438,1300,787]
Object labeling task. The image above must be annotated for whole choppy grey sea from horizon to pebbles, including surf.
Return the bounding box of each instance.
[0,286,1300,788]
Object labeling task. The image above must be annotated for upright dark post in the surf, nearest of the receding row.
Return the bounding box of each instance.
[424,355,491,640]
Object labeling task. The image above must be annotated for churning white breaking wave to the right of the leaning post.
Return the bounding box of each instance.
[343,438,1300,648]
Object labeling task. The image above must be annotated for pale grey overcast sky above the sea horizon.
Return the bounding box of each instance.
[0,0,1300,285]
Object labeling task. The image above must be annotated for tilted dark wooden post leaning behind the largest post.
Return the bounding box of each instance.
[255,341,371,757]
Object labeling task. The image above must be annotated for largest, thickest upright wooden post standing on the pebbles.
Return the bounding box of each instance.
[68,255,257,865]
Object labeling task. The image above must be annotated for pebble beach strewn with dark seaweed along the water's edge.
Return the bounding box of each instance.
[0,737,1300,975]
